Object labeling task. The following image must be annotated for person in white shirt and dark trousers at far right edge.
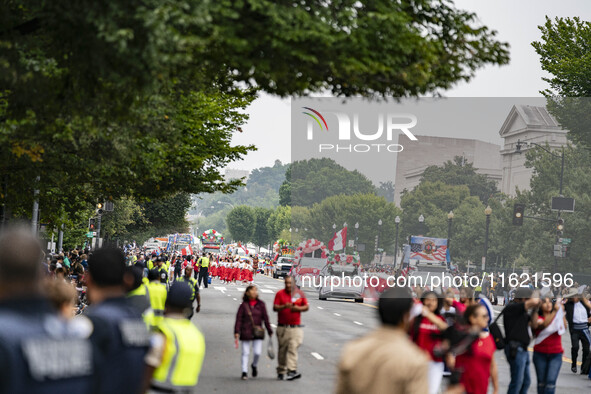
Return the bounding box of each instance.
[564,289,591,374]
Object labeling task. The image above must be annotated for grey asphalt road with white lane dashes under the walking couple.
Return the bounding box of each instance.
[193,275,591,394]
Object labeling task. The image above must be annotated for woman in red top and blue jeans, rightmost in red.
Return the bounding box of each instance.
[533,297,566,394]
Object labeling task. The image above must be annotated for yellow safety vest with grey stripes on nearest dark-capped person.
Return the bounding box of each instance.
[152,317,205,391]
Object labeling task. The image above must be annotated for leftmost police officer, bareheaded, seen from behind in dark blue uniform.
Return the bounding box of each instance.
[0,230,94,394]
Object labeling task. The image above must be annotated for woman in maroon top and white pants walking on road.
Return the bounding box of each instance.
[234,285,273,380]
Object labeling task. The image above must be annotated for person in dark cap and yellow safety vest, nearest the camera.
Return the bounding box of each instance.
[142,282,205,393]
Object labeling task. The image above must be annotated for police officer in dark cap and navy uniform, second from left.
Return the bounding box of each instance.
[87,248,150,394]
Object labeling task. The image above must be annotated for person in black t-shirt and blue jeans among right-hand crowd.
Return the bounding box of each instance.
[503,288,540,394]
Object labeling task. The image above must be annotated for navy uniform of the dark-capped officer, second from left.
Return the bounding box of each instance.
[87,297,150,394]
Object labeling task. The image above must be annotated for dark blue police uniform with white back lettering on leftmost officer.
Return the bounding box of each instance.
[0,297,94,394]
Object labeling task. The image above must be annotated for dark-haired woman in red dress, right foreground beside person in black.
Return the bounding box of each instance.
[455,304,499,394]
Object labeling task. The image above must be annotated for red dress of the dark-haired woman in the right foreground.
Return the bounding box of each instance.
[456,334,497,394]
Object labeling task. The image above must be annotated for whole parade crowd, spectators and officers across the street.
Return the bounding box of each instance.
[0,226,591,394]
